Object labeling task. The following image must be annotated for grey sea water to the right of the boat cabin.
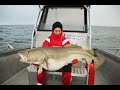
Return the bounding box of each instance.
[92,26,120,57]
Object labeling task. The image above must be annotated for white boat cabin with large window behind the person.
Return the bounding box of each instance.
[31,5,91,49]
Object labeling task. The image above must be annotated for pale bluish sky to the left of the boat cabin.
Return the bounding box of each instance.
[0,5,39,25]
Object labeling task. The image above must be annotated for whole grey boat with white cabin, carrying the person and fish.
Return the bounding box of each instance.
[0,5,120,85]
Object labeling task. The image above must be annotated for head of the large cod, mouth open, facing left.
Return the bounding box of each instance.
[18,49,45,64]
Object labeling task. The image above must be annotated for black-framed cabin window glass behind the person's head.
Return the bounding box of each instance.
[39,7,85,31]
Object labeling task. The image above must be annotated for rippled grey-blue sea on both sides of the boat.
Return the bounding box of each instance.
[0,25,120,56]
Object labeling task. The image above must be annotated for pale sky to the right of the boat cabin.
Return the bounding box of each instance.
[91,5,120,26]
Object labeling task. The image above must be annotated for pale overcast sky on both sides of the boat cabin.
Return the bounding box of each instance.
[0,5,120,26]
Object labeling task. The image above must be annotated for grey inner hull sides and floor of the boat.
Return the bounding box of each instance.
[0,50,120,85]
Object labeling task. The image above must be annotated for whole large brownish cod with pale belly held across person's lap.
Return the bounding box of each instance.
[18,44,104,71]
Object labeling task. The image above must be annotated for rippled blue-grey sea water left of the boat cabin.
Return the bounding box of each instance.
[0,25,33,53]
